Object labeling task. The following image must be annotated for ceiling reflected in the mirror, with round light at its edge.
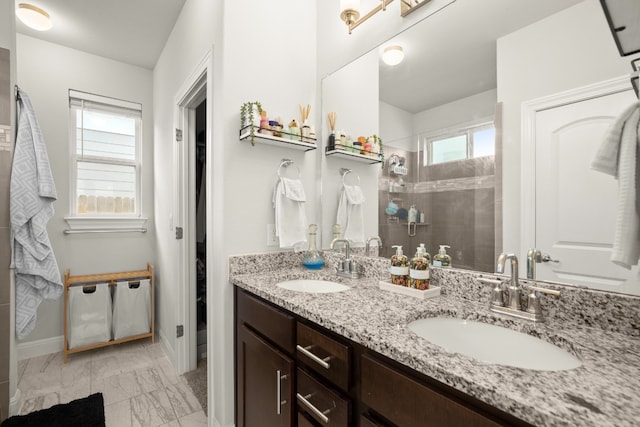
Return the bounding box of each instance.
[380,0,582,114]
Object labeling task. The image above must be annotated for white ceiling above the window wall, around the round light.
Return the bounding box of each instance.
[16,0,185,69]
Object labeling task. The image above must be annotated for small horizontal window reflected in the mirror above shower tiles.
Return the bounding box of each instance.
[423,124,496,166]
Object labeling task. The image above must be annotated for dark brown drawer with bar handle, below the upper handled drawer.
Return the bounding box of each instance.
[296,368,350,427]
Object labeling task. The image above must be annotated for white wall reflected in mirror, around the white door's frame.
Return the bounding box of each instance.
[497,0,638,255]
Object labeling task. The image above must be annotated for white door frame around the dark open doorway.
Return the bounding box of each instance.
[173,51,213,374]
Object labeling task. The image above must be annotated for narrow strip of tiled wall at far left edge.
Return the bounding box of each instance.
[0,48,13,422]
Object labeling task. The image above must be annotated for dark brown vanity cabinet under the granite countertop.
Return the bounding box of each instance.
[235,288,531,427]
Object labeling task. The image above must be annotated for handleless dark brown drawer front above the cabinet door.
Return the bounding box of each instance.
[237,290,296,354]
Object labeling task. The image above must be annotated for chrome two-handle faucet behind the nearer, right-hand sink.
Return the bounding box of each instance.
[479,250,560,322]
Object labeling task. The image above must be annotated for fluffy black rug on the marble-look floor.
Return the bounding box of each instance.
[0,393,105,427]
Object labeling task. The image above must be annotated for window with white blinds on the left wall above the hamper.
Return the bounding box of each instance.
[69,90,142,222]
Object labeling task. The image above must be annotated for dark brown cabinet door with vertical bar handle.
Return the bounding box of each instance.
[236,325,294,427]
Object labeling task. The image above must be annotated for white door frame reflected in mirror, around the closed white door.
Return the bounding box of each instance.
[519,75,632,257]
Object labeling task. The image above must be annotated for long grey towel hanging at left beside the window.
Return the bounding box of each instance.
[9,91,63,337]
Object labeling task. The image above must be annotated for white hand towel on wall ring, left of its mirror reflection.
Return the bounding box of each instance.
[273,178,307,248]
